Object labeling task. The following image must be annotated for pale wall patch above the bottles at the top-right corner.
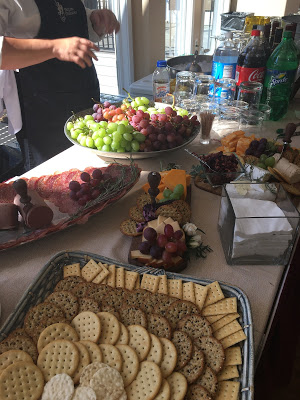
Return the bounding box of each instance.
[236,0,299,17]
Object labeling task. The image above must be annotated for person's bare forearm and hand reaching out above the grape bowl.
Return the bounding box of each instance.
[0,37,99,70]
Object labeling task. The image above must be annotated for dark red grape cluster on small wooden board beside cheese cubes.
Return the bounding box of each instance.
[139,224,187,266]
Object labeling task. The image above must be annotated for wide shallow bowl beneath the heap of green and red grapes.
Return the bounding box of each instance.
[64,103,200,160]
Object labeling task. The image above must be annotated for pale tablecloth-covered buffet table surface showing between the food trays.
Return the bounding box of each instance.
[0,98,300,364]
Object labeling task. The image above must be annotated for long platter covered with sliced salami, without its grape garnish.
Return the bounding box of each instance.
[0,163,141,251]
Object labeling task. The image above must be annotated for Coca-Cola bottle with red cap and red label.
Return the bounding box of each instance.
[235,29,267,89]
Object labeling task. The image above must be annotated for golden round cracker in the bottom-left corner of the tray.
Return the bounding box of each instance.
[0,361,44,400]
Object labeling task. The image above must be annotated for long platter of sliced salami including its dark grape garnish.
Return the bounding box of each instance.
[0,163,140,250]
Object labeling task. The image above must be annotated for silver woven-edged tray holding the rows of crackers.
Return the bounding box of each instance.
[0,250,254,400]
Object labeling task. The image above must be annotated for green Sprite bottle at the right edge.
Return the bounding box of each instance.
[261,31,298,121]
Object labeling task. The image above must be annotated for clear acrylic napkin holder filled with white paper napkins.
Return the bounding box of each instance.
[218,182,299,265]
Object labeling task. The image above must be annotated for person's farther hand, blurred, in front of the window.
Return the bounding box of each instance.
[90,8,120,36]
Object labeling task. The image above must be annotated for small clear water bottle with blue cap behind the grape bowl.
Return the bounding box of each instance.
[152,60,170,103]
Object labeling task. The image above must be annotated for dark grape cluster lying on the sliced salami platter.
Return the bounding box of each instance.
[69,169,111,206]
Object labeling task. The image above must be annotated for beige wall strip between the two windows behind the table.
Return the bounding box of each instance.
[131,0,166,81]
